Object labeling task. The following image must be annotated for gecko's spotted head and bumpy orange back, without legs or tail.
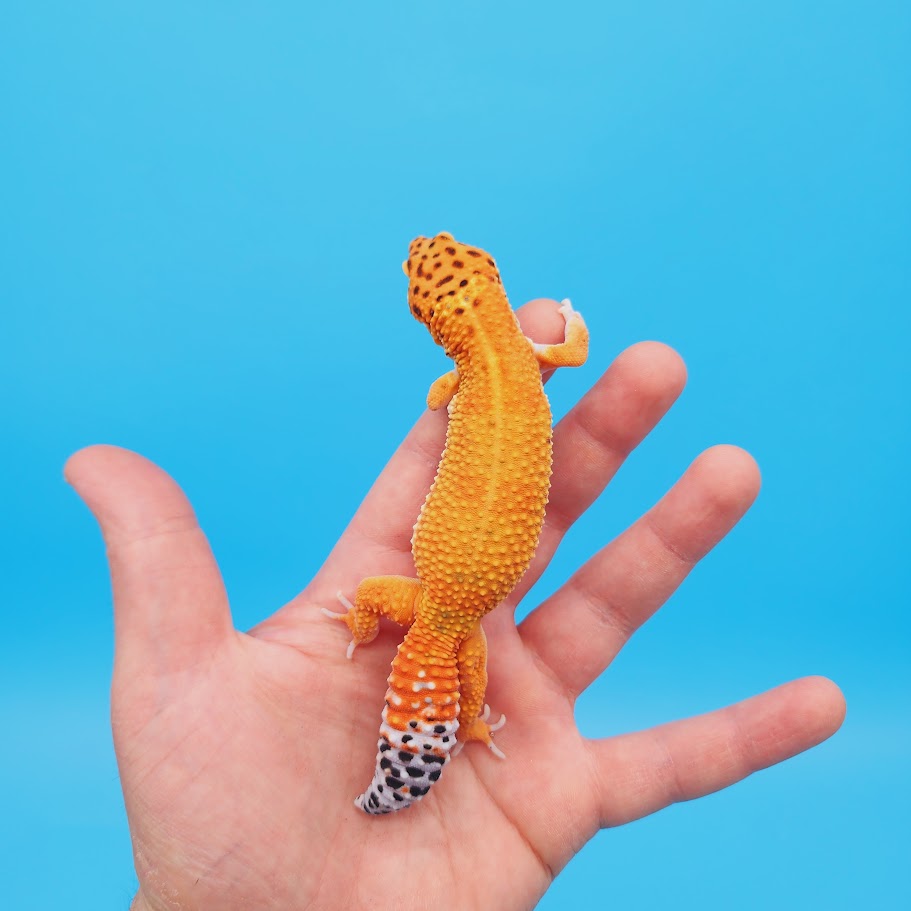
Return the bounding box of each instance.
[406,234,551,641]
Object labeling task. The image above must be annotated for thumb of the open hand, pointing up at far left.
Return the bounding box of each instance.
[64,446,232,674]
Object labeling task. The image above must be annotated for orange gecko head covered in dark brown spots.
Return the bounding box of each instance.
[402,233,500,347]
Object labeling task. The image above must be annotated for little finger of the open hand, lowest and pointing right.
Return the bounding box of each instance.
[590,677,845,827]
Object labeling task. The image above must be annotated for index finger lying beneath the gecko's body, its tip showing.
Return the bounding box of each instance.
[308,300,565,601]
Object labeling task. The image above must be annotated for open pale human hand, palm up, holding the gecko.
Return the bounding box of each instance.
[66,301,845,911]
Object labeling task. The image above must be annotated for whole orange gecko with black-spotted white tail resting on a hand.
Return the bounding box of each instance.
[323,234,588,815]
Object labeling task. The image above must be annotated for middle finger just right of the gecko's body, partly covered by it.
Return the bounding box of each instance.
[509,342,686,603]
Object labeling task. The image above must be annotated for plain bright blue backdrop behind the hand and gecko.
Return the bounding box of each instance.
[0,0,911,911]
